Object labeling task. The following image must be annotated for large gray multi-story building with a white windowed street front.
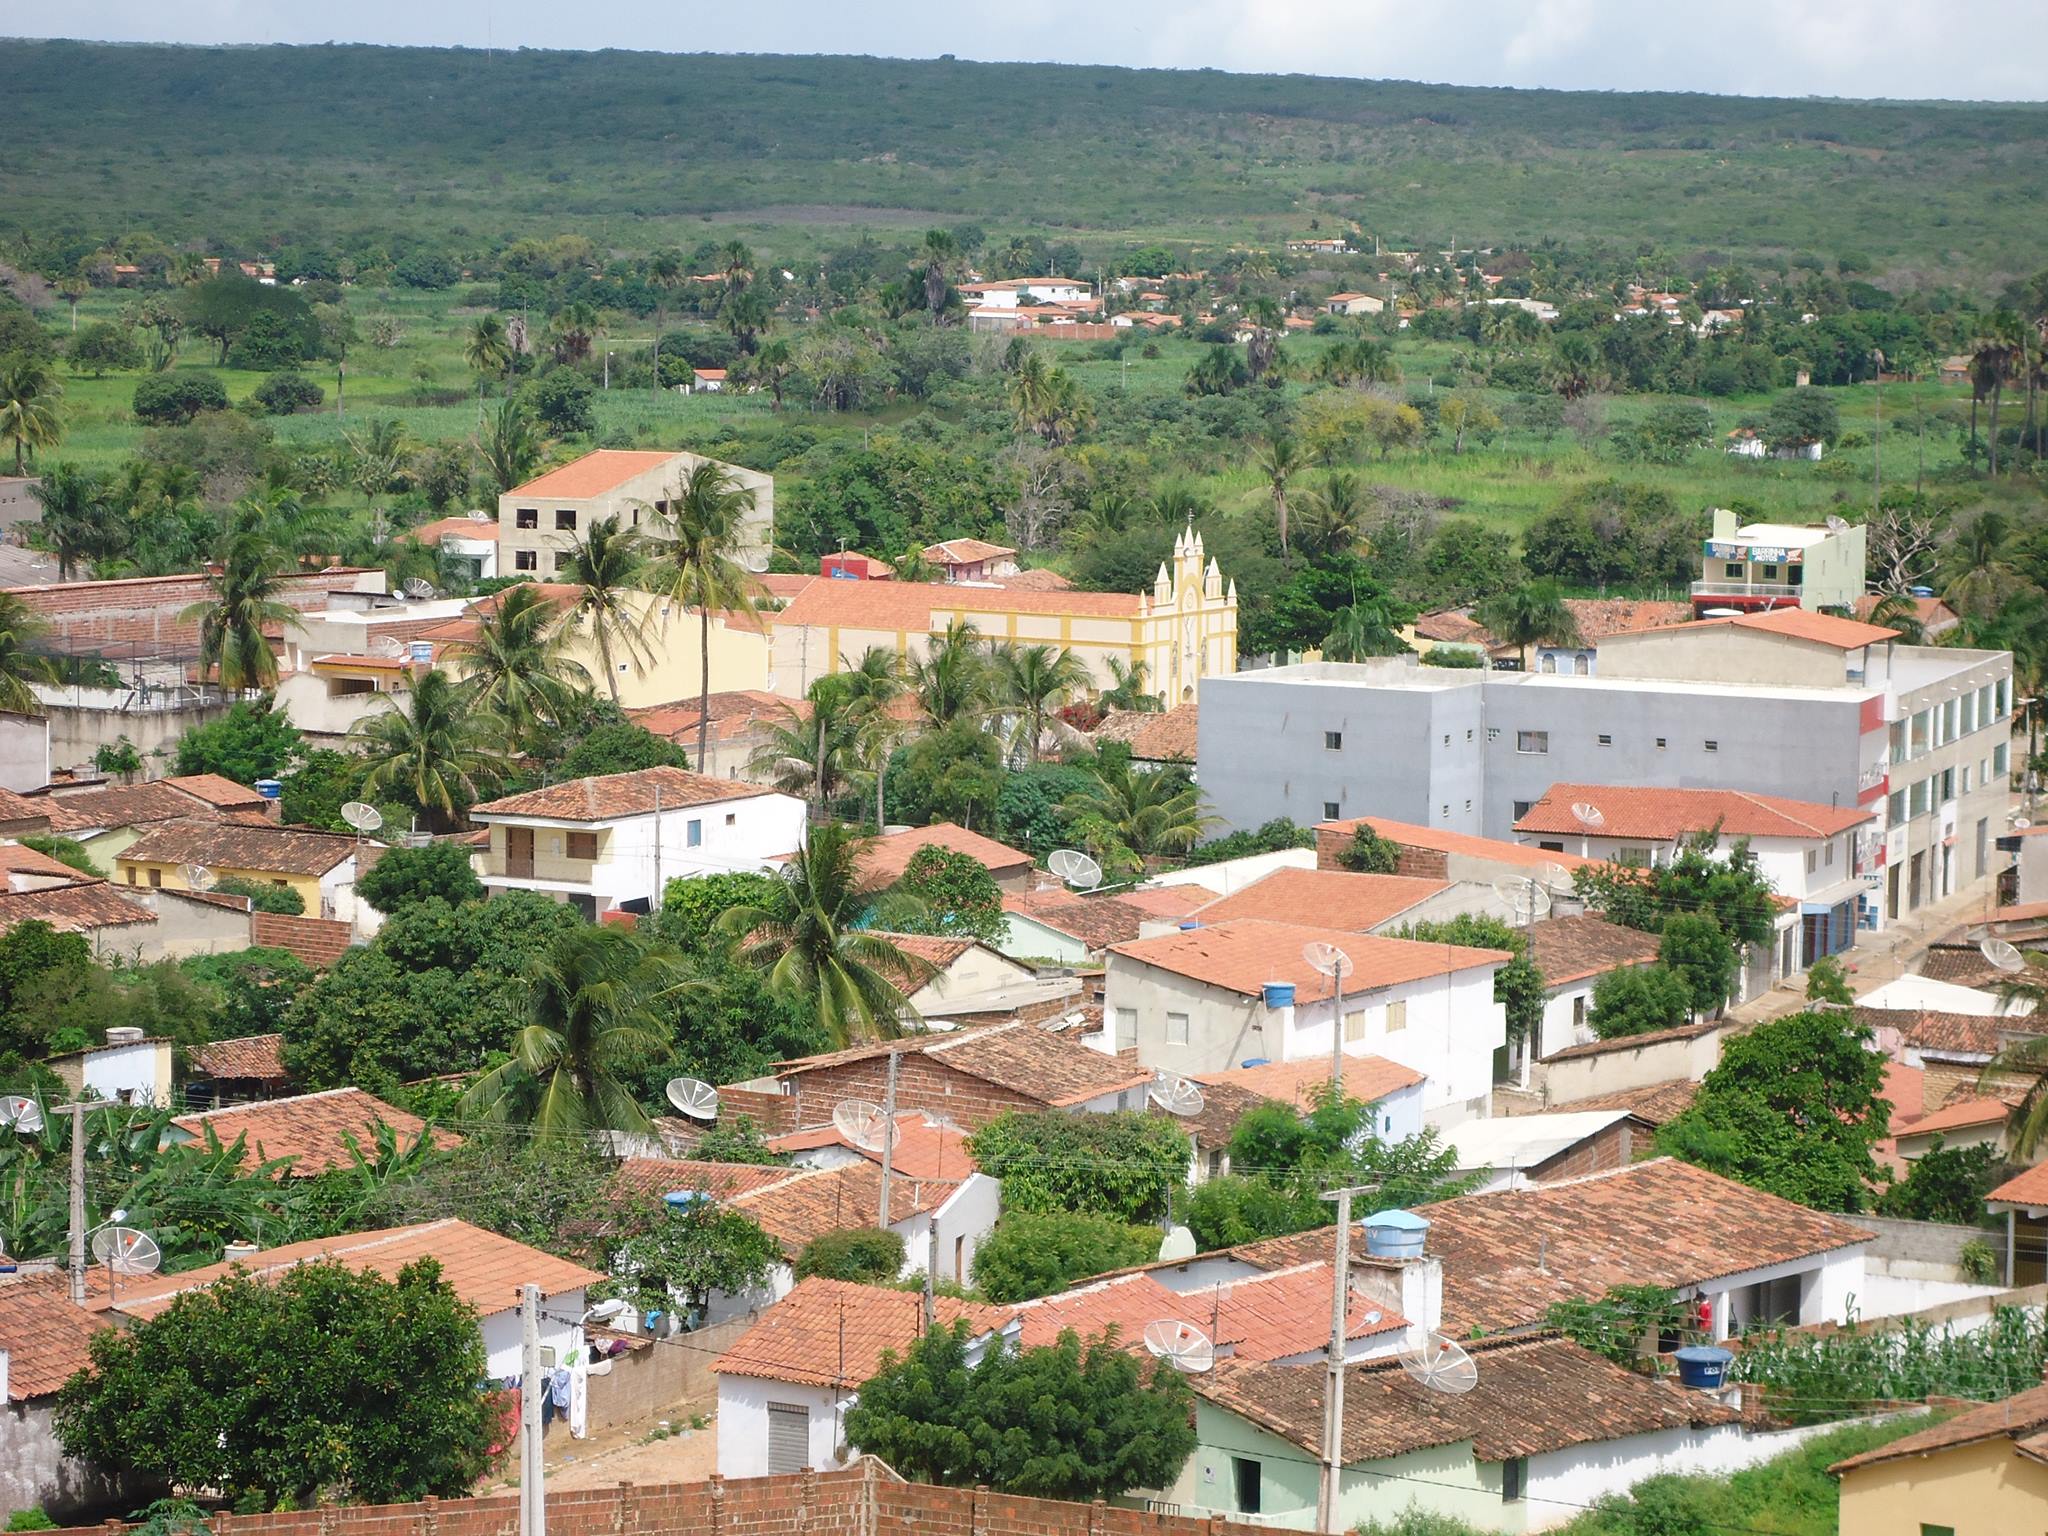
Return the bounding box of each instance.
[1196,610,2013,928]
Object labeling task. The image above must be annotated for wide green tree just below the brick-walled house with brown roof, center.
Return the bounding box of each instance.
[969,1110,1194,1223]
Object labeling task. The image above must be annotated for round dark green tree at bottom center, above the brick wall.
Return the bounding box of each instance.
[846,1323,1194,1499]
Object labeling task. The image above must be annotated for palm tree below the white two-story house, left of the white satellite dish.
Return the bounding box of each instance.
[463,926,684,1141]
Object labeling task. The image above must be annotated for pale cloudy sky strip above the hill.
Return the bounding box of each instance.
[16,0,2048,100]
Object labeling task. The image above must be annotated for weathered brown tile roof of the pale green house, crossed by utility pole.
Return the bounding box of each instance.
[1190,1335,1741,1466]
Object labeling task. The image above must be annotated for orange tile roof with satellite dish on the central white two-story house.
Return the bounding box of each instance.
[1112,918,1513,1001]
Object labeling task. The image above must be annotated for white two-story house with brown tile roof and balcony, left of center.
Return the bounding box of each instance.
[469,768,805,918]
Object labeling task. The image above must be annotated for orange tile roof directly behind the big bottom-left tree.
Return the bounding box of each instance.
[98,1219,604,1317]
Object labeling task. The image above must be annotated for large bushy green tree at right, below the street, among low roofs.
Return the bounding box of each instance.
[1657,1012,1892,1210]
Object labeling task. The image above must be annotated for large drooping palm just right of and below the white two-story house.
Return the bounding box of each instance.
[719,821,932,1044]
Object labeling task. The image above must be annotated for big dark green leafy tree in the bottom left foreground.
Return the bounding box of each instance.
[55,1260,496,1505]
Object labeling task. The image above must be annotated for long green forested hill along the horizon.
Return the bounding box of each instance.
[0,41,2048,283]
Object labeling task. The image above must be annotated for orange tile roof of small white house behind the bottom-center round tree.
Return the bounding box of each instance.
[711,1276,1010,1389]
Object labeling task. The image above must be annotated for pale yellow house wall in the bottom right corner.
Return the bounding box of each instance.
[1841,1436,2048,1536]
